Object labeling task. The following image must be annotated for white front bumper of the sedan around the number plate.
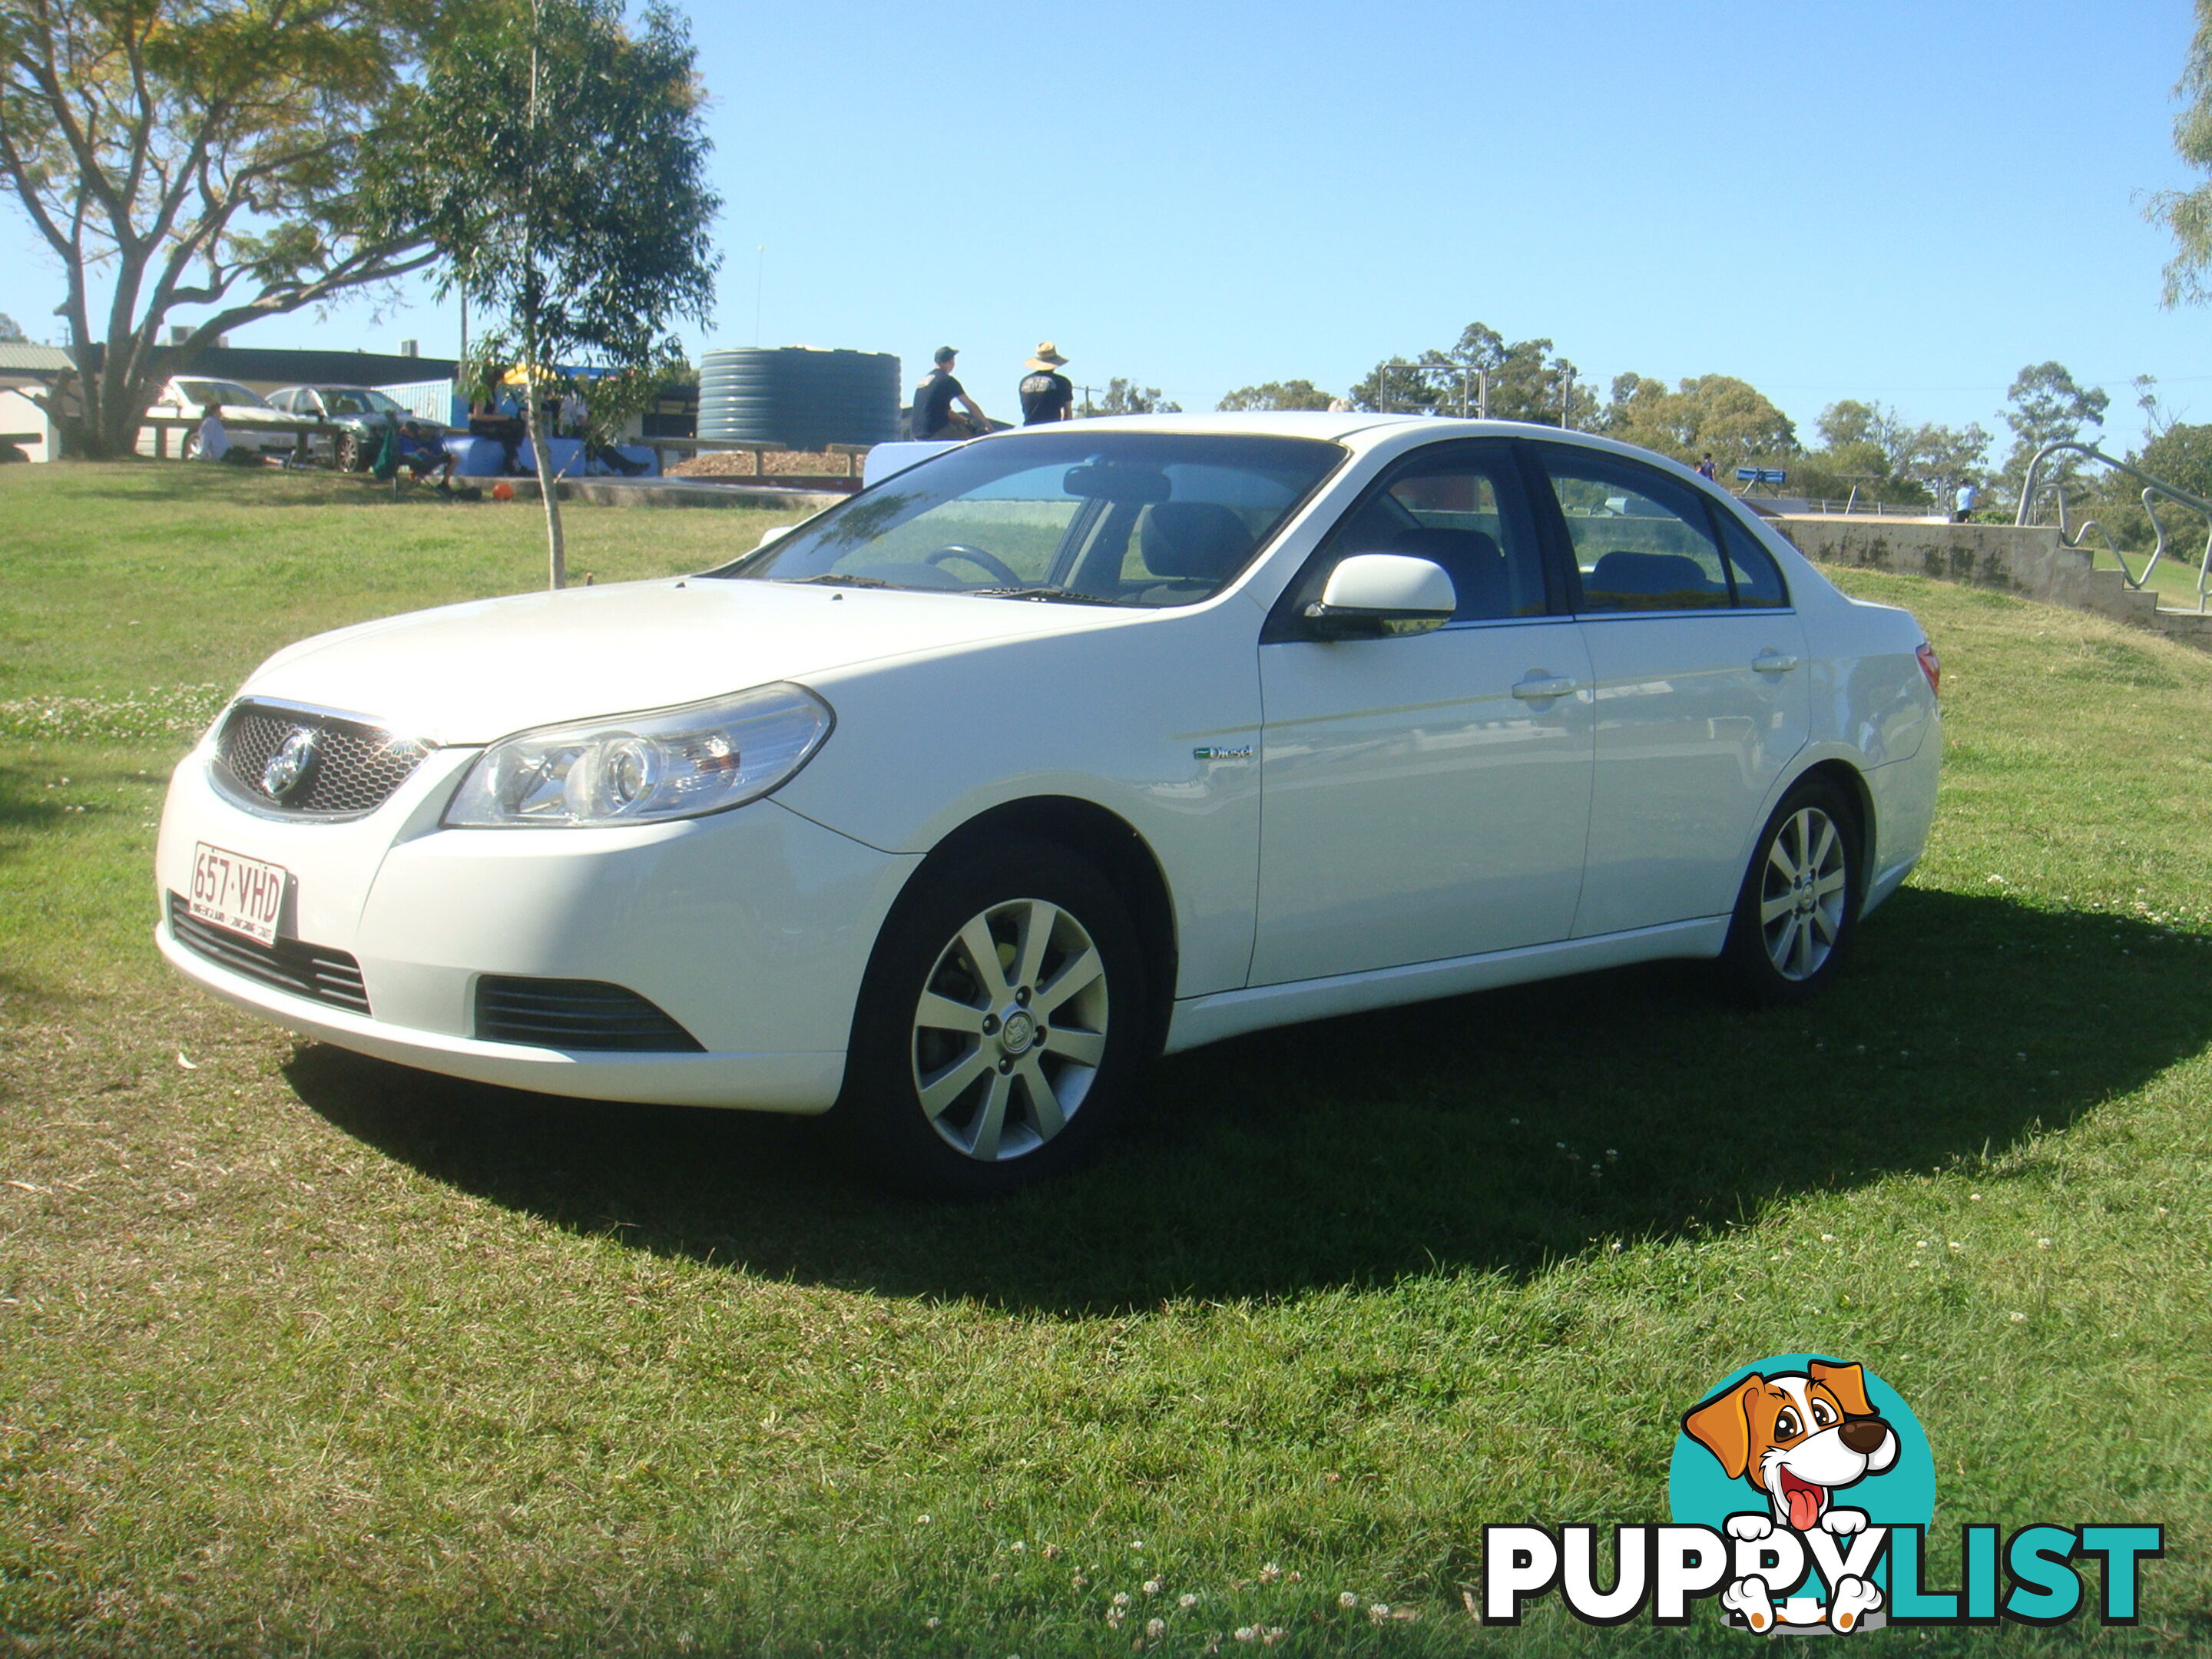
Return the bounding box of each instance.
[155,743,920,1113]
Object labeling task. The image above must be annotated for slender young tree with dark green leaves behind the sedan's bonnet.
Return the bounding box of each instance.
[387,0,721,588]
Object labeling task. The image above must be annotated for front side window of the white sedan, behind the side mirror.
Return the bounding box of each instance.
[1299,445,1546,621]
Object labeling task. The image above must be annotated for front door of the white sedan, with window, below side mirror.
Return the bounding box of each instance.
[1252,442,1593,985]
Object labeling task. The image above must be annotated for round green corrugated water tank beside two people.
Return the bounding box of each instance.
[699,345,898,449]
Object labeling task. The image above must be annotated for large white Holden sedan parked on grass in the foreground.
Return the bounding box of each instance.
[157,414,1942,1192]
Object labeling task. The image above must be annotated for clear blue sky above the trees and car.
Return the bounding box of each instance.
[0,0,2212,440]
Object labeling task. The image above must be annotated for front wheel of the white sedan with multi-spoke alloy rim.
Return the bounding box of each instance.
[836,839,1151,1199]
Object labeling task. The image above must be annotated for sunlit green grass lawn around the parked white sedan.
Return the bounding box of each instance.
[0,465,2212,1659]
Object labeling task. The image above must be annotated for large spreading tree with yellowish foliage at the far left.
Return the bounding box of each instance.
[0,0,458,455]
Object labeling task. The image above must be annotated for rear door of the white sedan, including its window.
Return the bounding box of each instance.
[1531,442,1812,938]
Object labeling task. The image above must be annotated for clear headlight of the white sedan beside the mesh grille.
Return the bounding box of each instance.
[445,686,832,830]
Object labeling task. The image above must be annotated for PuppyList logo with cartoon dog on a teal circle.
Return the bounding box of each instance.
[1482,1354,2166,1634]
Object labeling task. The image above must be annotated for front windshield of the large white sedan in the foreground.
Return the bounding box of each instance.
[712,432,1345,606]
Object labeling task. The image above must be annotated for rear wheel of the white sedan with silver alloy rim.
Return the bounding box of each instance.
[1721,777,1865,1006]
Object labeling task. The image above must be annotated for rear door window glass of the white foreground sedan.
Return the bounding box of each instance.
[1544,449,1734,611]
